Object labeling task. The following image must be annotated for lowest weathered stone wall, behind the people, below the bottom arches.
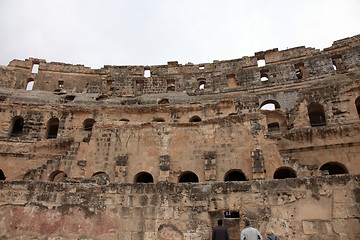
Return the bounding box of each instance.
[0,175,360,240]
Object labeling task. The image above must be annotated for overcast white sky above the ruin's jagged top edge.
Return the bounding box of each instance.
[0,0,360,68]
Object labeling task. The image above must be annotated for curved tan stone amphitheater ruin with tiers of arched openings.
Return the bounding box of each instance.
[0,35,360,240]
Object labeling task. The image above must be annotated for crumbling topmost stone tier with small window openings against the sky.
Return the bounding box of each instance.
[0,35,360,97]
